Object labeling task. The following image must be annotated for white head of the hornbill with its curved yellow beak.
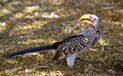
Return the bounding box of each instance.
[80,14,99,29]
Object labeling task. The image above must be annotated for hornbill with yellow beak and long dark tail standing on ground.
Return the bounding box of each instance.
[4,14,100,67]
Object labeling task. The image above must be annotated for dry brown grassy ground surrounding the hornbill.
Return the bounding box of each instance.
[0,0,123,76]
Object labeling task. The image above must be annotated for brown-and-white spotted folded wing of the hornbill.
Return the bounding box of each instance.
[54,35,89,61]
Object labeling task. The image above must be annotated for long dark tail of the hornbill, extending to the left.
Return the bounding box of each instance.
[3,45,52,58]
